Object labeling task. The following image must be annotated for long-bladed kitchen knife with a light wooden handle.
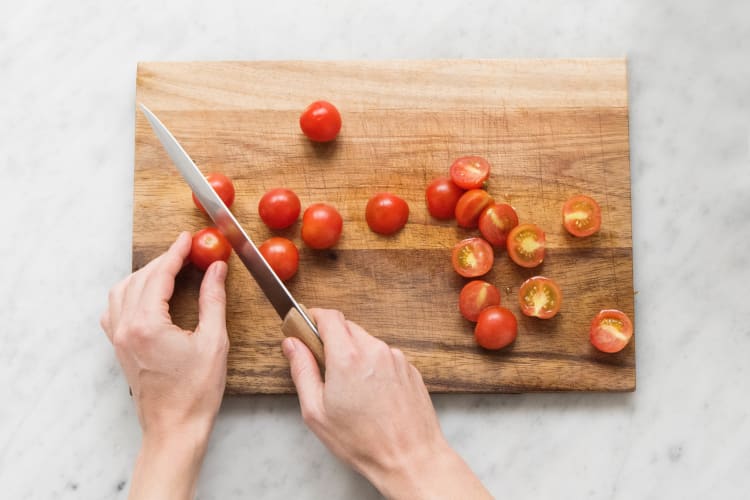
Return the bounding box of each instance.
[139,104,324,367]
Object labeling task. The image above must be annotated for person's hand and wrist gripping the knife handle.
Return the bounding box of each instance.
[282,309,490,499]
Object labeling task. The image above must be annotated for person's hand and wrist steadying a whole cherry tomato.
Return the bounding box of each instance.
[101,232,229,498]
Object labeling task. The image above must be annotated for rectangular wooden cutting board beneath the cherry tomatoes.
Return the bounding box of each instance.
[133,59,635,394]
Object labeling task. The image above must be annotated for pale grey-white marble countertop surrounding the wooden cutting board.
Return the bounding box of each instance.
[0,0,750,499]
